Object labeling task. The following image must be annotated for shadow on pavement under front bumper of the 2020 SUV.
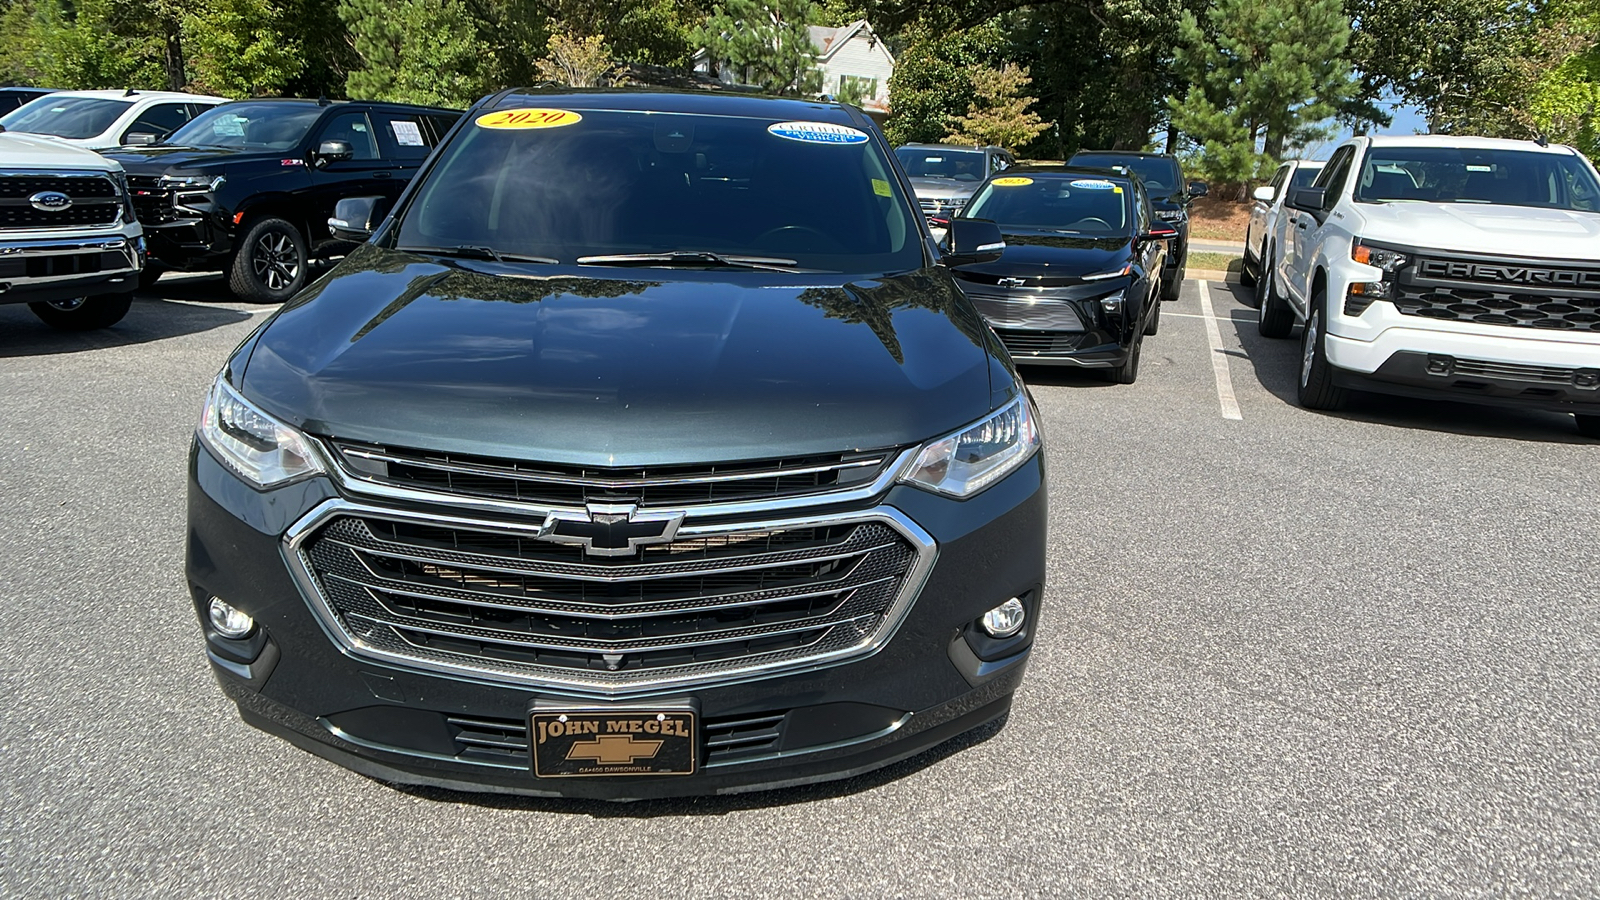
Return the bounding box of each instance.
[384,713,1010,818]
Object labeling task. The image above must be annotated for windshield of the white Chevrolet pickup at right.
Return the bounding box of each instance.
[1355,147,1600,211]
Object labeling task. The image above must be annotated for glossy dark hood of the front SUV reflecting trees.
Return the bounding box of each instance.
[235,245,1010,466]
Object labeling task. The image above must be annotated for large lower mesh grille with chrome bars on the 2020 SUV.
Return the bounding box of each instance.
[298,512,917,690]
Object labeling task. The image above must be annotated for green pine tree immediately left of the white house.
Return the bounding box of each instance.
[694,0,822,96]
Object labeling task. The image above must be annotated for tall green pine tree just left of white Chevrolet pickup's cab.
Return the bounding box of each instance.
[1171,0,1357,183]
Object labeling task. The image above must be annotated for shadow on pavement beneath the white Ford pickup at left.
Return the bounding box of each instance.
[0,295,250,359]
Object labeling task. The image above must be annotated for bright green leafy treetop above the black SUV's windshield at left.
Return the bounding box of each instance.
[182,0,306,96]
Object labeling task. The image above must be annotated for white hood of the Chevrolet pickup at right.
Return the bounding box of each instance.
[1354,202,1600,259]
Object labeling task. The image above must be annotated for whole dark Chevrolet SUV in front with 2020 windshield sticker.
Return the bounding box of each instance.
[187,91,1048,799]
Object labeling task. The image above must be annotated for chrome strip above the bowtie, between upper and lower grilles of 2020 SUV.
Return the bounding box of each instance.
[317,440,922,518]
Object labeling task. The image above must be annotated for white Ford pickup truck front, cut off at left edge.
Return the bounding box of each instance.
[0,133,144,330]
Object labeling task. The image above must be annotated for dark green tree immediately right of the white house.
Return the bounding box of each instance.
[885,22,1006,144]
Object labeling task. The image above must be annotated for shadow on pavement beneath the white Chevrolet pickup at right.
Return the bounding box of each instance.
[1218,285,1594,444]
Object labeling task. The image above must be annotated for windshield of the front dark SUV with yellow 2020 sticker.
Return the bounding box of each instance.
[397,109,923,272]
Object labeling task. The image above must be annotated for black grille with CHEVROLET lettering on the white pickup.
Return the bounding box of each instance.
[1394,258,1600,331]
